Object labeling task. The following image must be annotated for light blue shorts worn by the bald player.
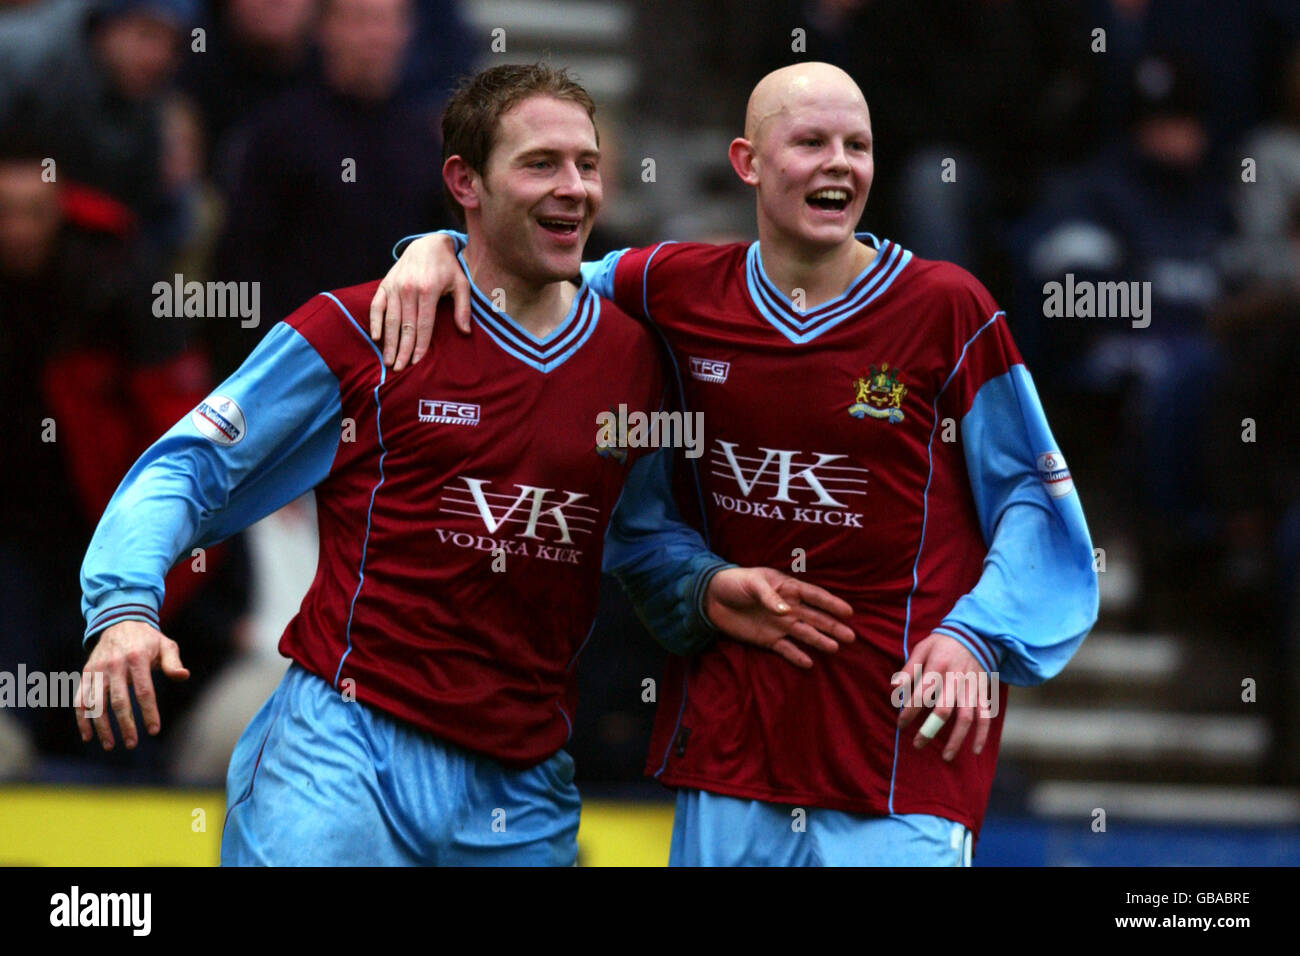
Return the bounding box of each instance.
[668,790,971,866]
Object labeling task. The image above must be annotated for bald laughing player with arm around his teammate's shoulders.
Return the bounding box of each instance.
[371,62,1097,865]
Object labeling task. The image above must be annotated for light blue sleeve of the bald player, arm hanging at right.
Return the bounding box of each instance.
[935,364,1097,685]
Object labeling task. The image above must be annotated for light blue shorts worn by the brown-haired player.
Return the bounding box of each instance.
[221,663,581,866]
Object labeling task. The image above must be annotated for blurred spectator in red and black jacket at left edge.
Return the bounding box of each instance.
[0,145,246,770]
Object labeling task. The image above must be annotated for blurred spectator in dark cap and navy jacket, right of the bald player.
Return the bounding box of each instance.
[1013,55,1230,616]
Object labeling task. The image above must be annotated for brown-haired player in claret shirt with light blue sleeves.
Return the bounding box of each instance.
[78,66,852,865]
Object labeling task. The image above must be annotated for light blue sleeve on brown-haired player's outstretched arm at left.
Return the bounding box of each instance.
[82,323,342,640]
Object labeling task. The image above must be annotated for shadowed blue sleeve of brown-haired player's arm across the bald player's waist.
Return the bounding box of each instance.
[603,449,736,654]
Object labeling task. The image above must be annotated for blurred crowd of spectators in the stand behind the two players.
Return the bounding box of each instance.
[0,0,1300,783]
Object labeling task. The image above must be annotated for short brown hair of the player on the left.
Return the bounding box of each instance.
[442,62,601,226]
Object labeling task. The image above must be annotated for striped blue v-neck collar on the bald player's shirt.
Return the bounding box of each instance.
[745,233,911,345]
